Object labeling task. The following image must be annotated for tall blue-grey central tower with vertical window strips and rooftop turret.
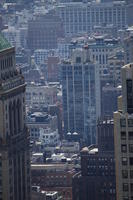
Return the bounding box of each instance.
[61,49,101,144]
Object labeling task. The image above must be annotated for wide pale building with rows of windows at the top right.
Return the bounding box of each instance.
[56,1,133,35]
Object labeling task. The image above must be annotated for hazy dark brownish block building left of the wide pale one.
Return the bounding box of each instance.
[27,13,64,50]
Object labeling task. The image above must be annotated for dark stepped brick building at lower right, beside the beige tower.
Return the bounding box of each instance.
[73,120,116,200]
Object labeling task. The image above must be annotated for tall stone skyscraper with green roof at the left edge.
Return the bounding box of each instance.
[0,35,30,200]
